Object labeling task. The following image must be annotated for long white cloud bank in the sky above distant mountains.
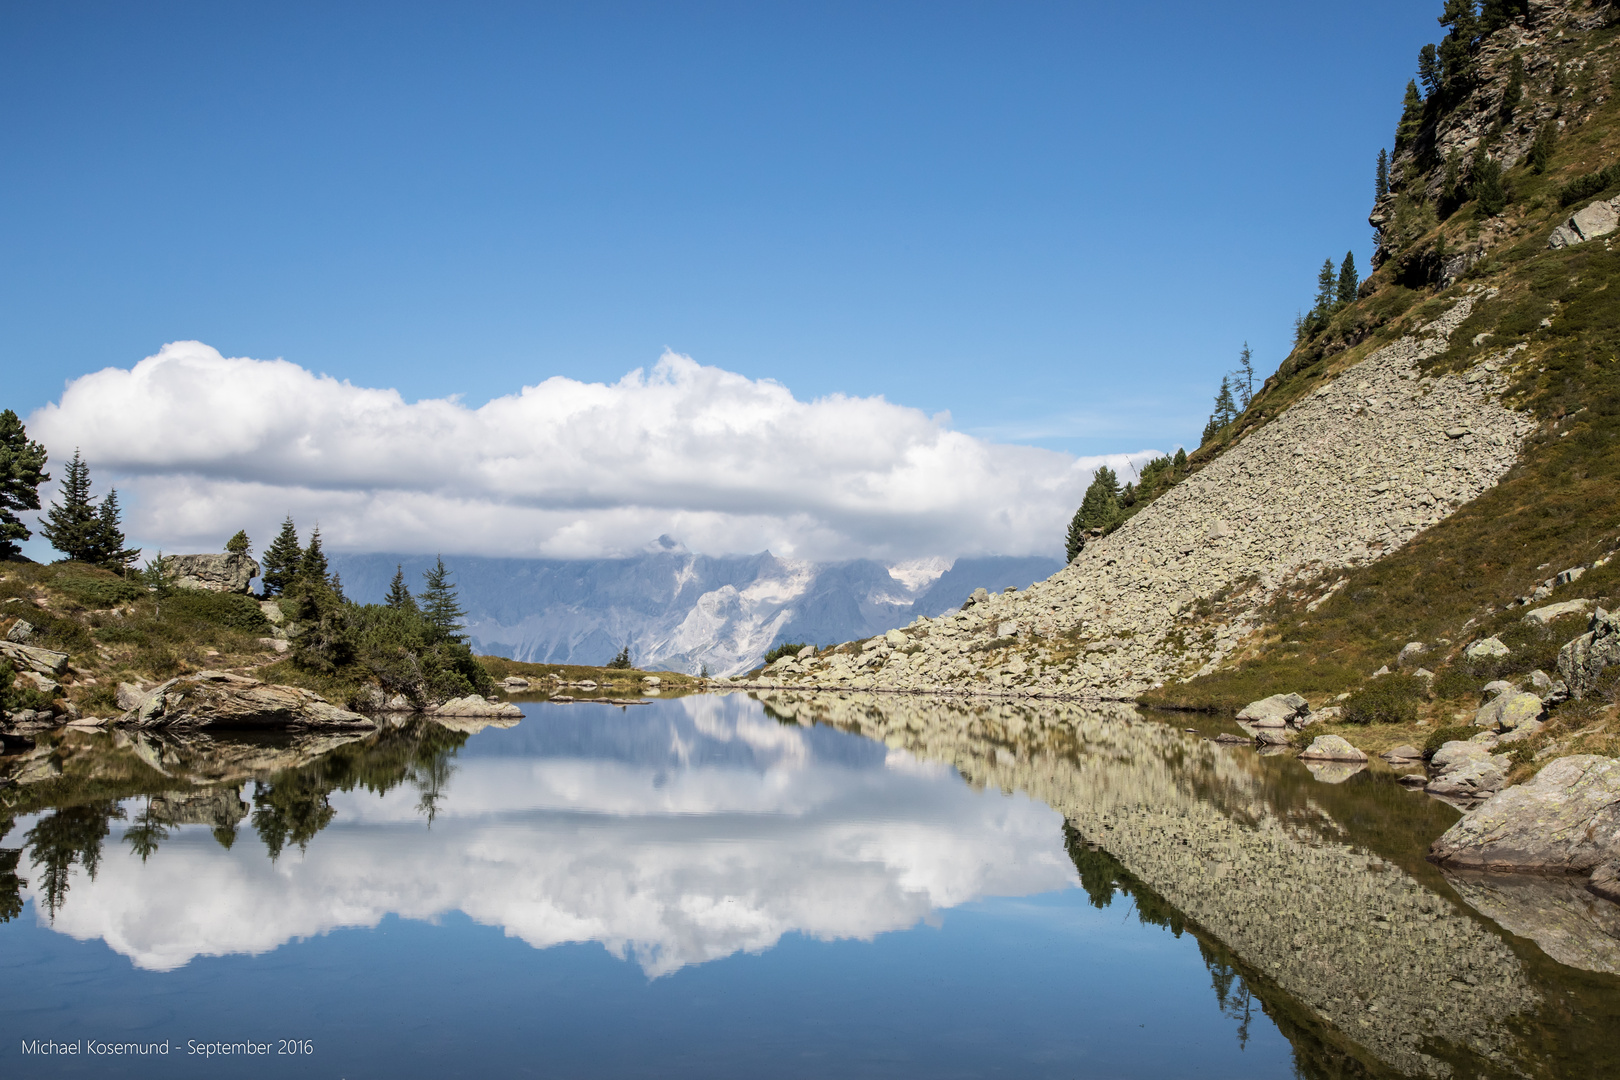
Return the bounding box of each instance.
[28,342,1152,560]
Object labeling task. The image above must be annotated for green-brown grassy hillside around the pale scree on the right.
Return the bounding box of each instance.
[1147,16,1620,773]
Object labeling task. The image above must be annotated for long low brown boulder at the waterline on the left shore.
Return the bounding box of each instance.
[118,672,377,729]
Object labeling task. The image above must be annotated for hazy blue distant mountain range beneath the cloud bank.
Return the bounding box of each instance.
[332,550,1063,675]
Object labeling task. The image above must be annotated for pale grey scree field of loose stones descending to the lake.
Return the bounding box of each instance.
[761,291,1534,698]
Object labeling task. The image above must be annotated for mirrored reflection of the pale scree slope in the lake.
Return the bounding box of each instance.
[761,693,1607,1075]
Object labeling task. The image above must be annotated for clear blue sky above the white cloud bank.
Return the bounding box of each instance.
[0,2,1439,557]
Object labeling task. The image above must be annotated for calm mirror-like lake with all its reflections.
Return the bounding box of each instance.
[0,695,1620,1077]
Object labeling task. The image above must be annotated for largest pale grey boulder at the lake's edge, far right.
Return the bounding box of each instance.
[1429,755,1620,874]
